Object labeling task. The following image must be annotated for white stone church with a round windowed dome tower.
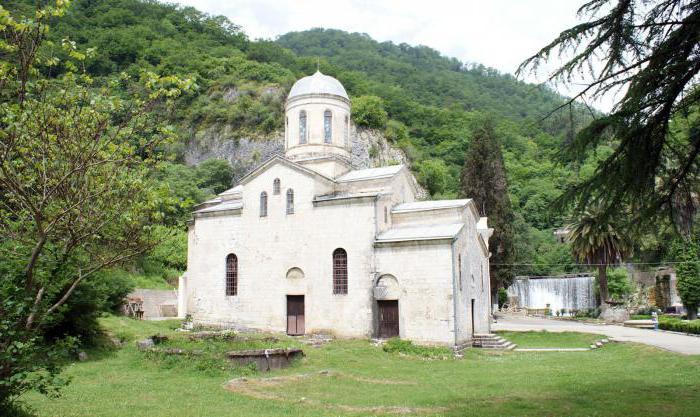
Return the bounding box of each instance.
[178,72,492,345]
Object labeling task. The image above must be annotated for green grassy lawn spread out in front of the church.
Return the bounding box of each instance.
[23,317,700,417]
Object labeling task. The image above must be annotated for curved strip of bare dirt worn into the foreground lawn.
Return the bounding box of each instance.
[224,371,448,414]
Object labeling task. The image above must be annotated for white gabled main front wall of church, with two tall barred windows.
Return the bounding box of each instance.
[187,164,375,337]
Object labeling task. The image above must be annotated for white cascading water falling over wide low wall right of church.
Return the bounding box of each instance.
[508,277,596,312]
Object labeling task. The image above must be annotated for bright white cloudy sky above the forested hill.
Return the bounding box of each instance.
[175,0,614,110]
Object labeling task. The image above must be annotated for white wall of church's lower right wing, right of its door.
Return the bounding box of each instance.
[375,240,455,345]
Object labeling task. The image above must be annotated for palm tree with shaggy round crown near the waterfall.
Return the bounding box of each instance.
[567,207,632,310]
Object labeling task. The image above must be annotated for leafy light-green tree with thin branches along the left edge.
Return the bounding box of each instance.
[0,0,193,408]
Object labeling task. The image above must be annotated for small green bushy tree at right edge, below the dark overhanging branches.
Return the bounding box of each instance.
[671,240,700,320]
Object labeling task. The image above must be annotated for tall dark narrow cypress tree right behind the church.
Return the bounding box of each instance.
[461,119,515,302]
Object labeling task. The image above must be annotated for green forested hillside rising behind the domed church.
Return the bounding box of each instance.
[3,0,593,278]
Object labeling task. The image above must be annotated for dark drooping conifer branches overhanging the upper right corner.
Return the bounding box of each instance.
[518,0,700,232]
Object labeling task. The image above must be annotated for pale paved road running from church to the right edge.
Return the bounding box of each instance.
[492,315,700,355]
